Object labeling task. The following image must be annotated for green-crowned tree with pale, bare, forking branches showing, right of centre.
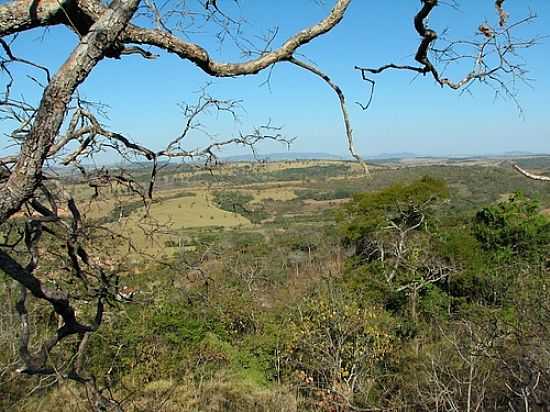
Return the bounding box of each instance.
[340,177,453,323]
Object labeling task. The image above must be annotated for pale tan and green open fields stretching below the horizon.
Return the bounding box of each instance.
[71,158,550,260]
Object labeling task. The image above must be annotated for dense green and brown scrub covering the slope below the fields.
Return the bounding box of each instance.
[0,160,550,412]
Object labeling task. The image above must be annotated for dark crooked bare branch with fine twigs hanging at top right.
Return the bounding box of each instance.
[356,0,540,111]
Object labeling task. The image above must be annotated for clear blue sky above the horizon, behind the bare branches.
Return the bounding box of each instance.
[1,0,550,156]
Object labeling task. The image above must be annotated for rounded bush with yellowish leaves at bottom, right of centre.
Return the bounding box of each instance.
[283,285,396,410]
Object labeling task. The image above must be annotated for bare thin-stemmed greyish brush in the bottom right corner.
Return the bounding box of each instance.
[415,294,550,411]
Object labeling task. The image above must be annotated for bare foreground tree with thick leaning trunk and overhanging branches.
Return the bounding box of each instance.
[0,0,535,400]
